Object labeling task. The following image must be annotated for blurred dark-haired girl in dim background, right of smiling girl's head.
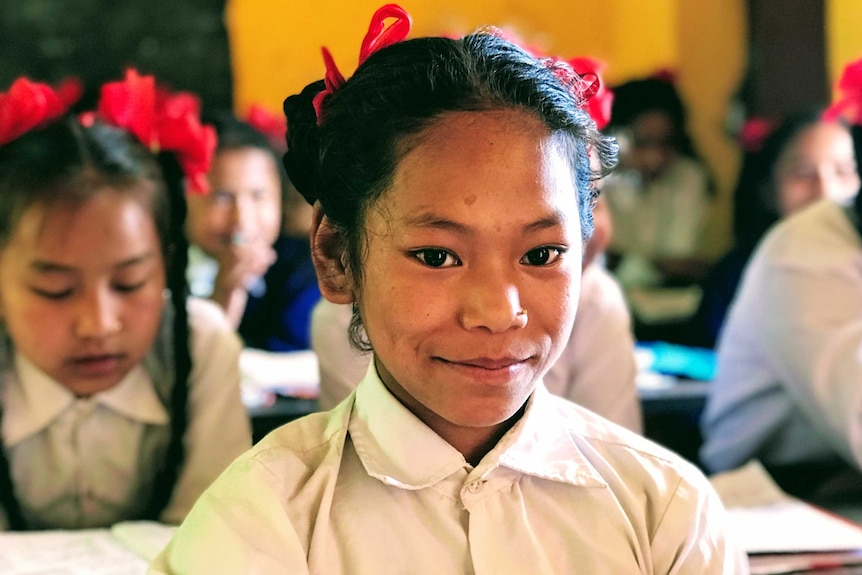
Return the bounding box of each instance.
[605,77,711,288]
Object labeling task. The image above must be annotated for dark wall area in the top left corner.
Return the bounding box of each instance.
[0,0,233,108]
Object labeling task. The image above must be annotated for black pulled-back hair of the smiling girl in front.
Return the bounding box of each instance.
[284,30,617,349]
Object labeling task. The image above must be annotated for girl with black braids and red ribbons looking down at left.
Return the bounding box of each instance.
[0,72,250,530]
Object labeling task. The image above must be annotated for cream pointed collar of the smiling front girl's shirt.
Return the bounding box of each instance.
[348,361,607,489]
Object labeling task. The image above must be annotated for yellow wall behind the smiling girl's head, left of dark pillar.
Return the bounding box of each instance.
[226,0,748,253]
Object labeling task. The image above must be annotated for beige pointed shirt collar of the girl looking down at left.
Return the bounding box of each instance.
[2,351,169,447]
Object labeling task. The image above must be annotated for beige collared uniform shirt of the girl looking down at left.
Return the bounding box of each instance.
[0,298,251,529]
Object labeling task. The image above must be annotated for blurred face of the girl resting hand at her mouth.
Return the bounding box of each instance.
[187,148,281,258]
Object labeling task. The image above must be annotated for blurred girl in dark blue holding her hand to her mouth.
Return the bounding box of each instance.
[186,115,320,351]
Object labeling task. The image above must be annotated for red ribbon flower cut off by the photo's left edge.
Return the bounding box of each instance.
[0,78,68,145]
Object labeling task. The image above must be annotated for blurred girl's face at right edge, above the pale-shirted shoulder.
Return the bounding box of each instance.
[775,122,859,216]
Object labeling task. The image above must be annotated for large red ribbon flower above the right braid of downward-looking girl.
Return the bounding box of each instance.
[81,69,216,194]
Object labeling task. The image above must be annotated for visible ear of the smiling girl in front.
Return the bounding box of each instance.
[311,202,354,303]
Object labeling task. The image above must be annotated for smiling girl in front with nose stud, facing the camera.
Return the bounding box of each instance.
[154,5,745,575]
